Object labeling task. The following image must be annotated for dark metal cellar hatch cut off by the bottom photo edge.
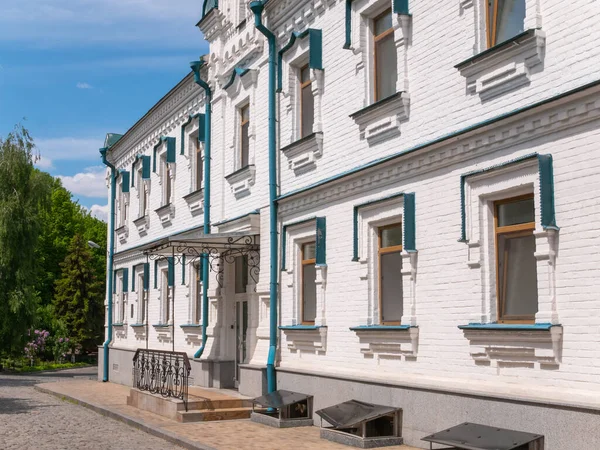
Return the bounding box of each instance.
[423,422,544,450]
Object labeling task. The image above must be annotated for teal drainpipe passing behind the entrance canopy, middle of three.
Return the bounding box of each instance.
[190,58,212,358]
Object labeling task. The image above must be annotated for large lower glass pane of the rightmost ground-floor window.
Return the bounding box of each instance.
[498,234,538,318]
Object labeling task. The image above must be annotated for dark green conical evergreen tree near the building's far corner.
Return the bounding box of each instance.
[54,234,104,350]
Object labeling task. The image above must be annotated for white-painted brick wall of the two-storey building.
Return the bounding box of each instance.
[103,0,600,400]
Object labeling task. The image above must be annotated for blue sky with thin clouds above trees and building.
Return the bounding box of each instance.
[0,0,208,218]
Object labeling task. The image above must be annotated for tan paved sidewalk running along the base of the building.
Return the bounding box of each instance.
[30,380,417,450]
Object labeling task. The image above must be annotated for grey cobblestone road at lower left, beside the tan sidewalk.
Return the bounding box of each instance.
[0,367,180,450]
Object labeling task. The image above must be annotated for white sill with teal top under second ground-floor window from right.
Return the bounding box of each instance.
[350,325,419,361]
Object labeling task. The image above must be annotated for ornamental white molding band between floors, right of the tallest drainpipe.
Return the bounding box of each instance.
[279,88,600,217]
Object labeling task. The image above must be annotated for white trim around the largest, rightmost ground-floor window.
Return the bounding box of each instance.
[465,159,559,324]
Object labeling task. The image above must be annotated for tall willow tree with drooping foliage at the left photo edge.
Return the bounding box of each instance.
[0,125,50,353]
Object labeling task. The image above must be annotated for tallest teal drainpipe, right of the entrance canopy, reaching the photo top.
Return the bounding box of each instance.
[250,1,278,392]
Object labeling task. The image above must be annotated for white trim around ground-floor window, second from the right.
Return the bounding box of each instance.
[358,198,417,326]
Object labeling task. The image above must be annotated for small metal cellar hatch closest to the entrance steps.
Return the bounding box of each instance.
[250,390,313,428]
